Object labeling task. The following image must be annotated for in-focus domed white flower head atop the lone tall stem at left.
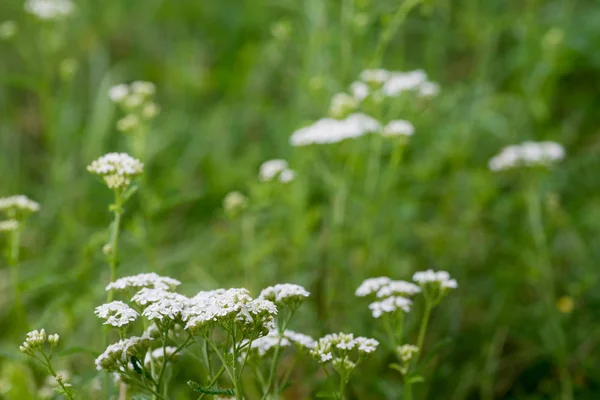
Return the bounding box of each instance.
[87,153,144,189]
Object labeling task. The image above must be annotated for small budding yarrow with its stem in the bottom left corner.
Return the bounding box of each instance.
[19,329,74,400]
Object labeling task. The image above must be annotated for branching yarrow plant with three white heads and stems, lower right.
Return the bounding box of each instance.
[355,270,458,399]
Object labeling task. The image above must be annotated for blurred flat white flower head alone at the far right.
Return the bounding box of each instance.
[488,141,565,171]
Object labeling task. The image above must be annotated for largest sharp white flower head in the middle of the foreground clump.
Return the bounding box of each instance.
[183,289,277,331]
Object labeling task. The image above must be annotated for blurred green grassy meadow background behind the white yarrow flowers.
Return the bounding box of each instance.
[0,0,600,400]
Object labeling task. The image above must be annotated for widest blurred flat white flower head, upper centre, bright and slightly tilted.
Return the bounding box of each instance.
[290,113,381,147]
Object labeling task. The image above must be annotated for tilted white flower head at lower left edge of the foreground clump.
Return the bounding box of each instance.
[96,336,152,372]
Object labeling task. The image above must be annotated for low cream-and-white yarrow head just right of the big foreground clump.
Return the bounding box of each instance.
[310,333,379,363]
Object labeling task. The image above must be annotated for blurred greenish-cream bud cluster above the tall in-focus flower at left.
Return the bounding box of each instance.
[108,81,160,133]
